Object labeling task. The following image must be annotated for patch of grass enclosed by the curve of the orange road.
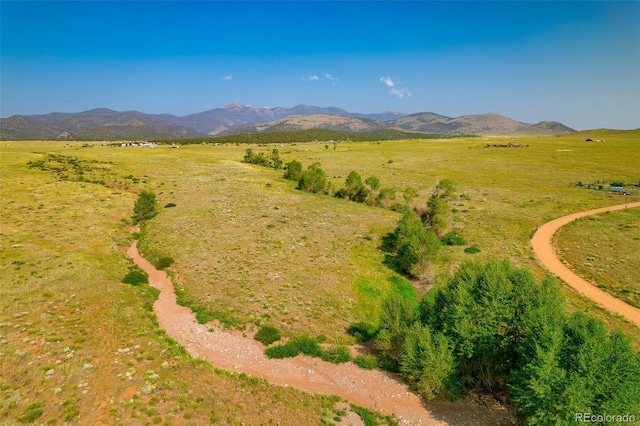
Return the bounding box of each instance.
[556,209,640,307]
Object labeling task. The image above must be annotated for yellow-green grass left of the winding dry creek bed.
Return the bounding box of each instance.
[0,142,358,425]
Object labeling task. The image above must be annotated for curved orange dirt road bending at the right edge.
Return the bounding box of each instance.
[531,202,640,327]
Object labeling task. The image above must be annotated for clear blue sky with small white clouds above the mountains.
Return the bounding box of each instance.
[0,1,640,129]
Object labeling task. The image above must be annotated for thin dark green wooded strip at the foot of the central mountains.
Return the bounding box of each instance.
[168,129,448,145]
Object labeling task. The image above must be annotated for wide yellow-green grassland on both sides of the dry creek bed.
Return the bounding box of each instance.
[0,131,640,424]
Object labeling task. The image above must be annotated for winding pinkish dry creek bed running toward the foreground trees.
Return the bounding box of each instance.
[127,241,512,425]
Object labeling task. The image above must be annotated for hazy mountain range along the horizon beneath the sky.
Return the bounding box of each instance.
[0,103,575,140]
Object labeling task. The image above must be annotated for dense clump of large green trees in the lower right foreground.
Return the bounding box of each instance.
[376,261,640,425]
